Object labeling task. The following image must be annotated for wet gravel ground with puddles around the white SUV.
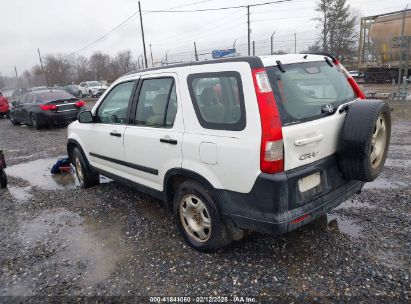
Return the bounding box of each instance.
[0,102,411,303]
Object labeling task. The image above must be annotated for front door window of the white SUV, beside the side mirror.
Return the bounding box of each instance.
[97,81,135,124]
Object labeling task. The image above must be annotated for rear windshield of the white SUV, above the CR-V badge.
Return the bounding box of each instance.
[266,61,356,125]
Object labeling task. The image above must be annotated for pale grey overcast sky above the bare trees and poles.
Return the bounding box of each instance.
[0,0,407,76]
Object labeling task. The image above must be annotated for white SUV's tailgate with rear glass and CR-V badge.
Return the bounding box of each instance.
[266,56,357,171]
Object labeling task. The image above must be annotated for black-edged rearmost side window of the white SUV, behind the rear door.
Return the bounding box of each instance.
[187,72,246,131]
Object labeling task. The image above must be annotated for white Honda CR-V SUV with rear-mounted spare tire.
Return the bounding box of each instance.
[67,54,391,251]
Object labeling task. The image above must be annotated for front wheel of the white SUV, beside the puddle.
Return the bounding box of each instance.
[71,147,100,188]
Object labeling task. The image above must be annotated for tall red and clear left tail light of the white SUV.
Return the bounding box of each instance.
[252,68,284,174]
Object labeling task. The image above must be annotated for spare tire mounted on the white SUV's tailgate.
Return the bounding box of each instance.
[338,100,391,182]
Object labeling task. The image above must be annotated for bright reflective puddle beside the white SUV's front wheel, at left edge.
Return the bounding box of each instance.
[6,157,75,190]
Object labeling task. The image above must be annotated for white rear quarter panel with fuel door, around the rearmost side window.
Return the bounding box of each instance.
[179,62,261,193]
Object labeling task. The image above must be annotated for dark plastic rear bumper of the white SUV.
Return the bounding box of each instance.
[217,156,364,234]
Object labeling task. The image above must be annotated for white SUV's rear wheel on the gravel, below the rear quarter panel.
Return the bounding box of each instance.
[173,181,232,252]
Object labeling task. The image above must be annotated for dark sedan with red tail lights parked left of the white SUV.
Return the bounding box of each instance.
[10,90,85,129]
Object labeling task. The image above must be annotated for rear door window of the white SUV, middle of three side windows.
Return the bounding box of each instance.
[135,78,177,128]
